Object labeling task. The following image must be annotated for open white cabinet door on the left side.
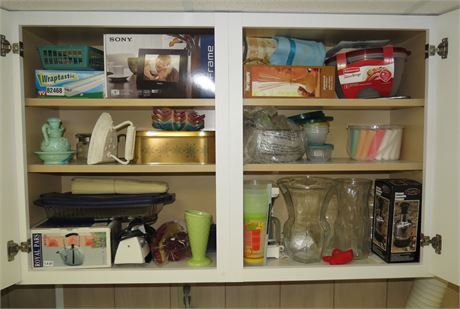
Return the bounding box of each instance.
[0,10,20,289]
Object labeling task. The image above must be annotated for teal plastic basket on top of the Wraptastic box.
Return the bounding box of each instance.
[38,45,104,71]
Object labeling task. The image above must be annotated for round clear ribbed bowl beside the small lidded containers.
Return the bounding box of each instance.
[244,129,305,163]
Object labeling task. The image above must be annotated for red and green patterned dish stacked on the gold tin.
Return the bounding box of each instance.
[152,108,205,131]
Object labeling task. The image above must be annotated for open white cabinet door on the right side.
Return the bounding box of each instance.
[427,10,460,285]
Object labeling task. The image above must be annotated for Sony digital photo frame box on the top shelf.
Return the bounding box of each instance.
[104,34,215,98]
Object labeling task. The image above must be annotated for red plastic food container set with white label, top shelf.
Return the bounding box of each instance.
[326,46,410,98]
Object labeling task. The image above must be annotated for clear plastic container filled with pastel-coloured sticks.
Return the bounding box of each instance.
[347,125,403,160]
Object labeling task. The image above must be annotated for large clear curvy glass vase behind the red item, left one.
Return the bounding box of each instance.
[278,176,334,263]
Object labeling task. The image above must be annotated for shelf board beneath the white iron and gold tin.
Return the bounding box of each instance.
[28,164,216,174]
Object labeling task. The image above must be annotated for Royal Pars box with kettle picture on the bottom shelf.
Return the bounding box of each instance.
[31,219,121,269]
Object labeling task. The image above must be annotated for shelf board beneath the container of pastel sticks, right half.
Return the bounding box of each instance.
[244,159,423,172]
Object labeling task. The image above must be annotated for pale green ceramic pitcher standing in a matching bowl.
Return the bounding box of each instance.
[40,118,70,152]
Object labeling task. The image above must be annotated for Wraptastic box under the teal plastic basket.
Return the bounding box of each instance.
[35,70,105,98]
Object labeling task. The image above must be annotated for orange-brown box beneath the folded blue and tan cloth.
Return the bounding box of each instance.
[244,65,335,98]
